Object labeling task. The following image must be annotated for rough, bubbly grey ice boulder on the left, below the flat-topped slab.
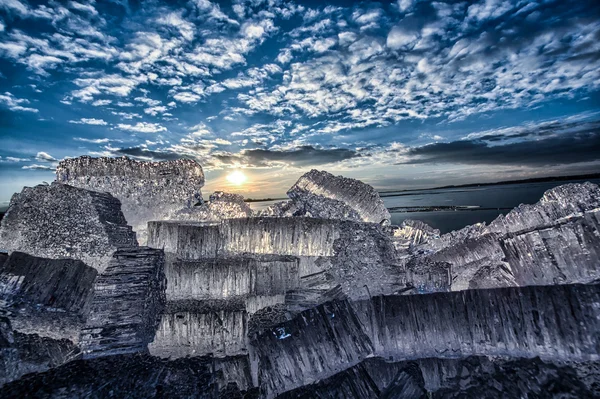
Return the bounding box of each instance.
[0,183,137,272]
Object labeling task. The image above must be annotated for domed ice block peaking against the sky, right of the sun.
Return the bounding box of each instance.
[288,169,390,224]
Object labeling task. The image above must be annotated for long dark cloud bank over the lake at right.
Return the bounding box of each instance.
[404,127,600,167]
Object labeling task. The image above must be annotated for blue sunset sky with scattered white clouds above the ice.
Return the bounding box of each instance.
[0,0,600,206]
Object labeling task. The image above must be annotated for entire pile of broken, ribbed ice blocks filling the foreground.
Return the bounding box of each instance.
[0,157,600,399]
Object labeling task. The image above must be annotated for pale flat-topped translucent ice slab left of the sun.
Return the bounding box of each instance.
[56,156,204,245]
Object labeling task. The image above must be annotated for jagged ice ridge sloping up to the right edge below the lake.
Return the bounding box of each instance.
[410,183,600,290]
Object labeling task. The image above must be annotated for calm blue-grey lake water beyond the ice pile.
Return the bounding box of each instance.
[249,179,600,233]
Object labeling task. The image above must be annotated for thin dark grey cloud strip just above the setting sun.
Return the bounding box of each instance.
[215,145,360,167]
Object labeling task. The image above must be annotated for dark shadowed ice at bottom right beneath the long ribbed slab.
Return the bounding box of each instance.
[278,356,598,399]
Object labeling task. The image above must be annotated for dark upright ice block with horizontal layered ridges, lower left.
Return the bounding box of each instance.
[81,247,165,358]
